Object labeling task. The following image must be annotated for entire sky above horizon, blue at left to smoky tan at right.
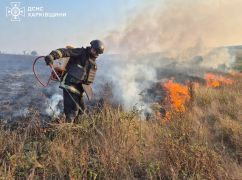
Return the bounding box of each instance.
[0,0,242,57]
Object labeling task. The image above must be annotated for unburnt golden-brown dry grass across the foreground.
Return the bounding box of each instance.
[0,78,242,179]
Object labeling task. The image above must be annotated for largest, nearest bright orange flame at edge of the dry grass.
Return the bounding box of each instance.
[163,80,190,112]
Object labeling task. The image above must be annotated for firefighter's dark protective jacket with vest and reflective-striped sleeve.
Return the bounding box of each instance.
[49,47,97,94]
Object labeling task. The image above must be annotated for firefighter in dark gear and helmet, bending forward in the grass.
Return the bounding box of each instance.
[45,40,104,122]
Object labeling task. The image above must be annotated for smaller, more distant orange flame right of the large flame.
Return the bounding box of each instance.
[205,73,233,88]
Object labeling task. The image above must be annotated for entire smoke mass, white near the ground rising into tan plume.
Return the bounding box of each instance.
[98,0,242,109]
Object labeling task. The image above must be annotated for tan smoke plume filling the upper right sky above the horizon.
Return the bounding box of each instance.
[105,0,242,58]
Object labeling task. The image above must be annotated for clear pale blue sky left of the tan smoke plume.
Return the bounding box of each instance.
[0,0,144,55]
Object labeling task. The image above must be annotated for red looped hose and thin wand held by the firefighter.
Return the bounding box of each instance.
[33,56,84,113]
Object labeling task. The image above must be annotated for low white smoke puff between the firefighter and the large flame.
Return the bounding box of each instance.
[112,64,156,109]
